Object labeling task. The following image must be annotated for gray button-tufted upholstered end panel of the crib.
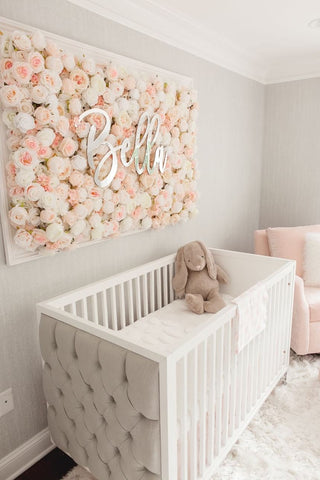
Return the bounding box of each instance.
[40,315,160,480]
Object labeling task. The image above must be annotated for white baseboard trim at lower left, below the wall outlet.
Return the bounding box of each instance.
[0,428,55,480]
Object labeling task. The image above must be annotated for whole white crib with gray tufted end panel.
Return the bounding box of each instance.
[38,249,295,480]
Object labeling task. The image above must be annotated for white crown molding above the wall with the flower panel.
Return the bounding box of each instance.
[68,0,266,83]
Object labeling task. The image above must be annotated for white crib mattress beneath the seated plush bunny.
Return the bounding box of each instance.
[117,295,233,354]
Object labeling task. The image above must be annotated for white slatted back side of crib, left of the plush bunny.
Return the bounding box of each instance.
[51,255,175,330]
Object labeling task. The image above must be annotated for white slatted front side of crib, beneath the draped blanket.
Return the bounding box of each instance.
[169,266,294,480]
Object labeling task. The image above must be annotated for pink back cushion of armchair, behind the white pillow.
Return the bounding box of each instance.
[267,225,320,277]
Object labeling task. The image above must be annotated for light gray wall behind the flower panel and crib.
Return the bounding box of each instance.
[0,0,264,458]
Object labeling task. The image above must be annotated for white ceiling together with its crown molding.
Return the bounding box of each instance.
[70,0,320,83]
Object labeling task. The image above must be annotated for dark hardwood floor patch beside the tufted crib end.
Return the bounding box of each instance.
[16,448,75,480]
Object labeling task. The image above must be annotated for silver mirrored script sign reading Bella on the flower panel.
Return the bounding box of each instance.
[79,108,168,188]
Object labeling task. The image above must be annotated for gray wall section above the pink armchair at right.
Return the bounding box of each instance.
[260,78,320,228]
